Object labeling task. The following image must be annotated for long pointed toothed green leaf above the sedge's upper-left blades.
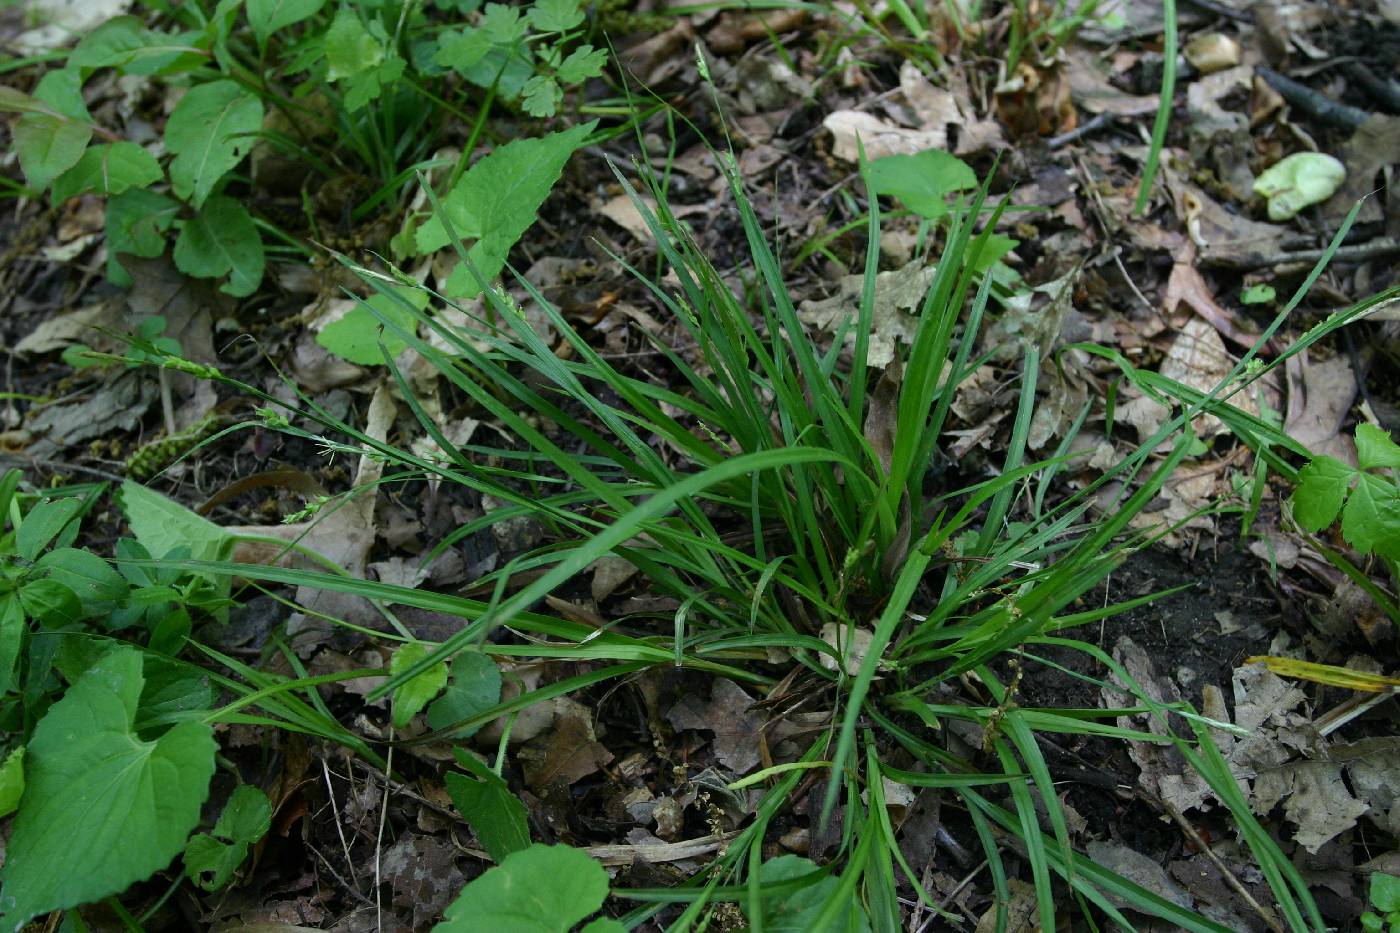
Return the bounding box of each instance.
[416,120,596,297]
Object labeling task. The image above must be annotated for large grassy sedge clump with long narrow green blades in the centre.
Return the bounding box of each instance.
[103,121,1360,930]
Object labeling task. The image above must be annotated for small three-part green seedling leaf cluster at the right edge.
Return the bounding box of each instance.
[1294,424,1400,560]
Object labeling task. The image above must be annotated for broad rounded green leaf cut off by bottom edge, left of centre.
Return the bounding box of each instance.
[433,845,608,933]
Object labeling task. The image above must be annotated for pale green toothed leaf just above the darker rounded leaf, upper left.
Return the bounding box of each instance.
[165,81,263,209]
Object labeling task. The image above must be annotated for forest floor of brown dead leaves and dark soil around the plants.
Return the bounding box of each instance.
[0,0,1400,933]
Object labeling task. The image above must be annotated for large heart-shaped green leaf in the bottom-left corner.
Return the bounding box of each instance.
[0,647,217,930]
